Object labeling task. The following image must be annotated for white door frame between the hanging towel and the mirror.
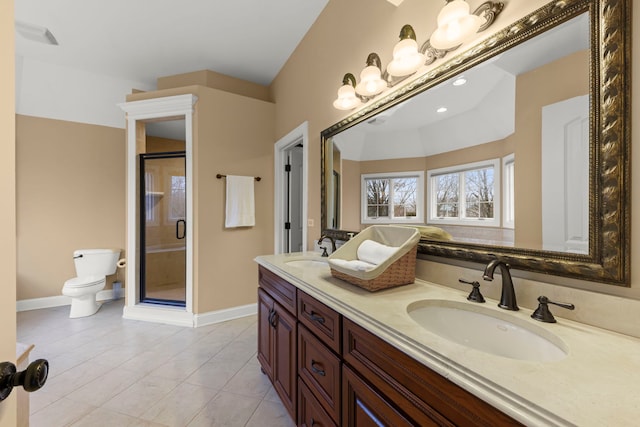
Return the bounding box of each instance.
[273,122,309,254]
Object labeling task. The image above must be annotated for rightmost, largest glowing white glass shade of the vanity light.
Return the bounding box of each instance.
[430,0,483,49]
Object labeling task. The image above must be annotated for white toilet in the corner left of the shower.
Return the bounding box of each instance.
[62,249,120,319]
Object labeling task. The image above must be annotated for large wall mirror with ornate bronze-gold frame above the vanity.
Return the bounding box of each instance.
[321,0,631,286]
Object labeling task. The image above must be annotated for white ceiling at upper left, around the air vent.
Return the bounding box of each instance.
[15,0,328,85]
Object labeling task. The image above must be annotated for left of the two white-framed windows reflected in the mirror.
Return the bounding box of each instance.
[362,171,424,223]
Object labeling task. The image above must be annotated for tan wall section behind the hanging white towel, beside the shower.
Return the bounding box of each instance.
[127,86,275,313]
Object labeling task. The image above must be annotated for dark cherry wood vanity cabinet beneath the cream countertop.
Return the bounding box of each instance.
[258,266,521,427]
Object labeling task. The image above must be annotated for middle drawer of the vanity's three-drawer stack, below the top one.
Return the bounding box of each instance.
[298,325,340,423]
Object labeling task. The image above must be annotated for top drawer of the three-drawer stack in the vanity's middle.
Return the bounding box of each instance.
[298,291,342,354]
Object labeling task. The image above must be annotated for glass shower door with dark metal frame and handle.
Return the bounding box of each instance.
[140,151,188,307]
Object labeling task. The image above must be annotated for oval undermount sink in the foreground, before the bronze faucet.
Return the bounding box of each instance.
[407,300,568,362]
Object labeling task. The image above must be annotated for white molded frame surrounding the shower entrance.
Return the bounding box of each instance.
[118,94,198,326]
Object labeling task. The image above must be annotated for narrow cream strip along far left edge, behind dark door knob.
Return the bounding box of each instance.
[0,0,17,427]
